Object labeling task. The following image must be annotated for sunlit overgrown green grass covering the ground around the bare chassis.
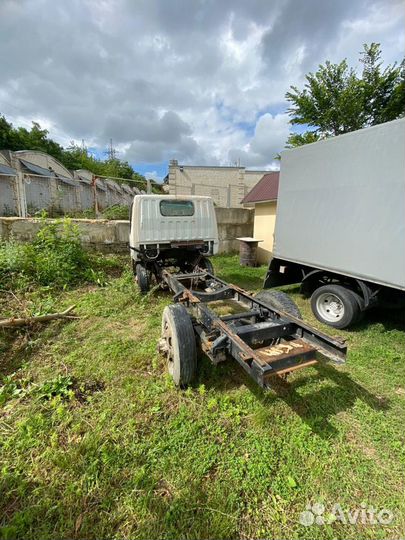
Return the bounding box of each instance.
[0,256,405,540]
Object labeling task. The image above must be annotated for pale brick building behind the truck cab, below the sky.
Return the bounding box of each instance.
[169,160,269,208]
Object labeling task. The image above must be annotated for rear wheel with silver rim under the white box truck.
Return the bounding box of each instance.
[311,285,361,328]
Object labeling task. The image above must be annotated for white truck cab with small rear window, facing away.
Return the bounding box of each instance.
[129,195,218,292]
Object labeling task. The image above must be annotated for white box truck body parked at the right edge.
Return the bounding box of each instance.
[266,118,405,327]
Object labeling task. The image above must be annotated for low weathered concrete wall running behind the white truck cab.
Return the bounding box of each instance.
[0,208,253,253]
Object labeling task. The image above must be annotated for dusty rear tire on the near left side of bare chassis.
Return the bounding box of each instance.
[160,304,197,386]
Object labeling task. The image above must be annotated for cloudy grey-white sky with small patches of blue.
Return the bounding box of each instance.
[0,0,405,178]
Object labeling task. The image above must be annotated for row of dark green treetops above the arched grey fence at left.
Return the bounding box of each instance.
[0,115,146,184]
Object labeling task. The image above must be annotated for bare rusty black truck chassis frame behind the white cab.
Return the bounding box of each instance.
[159,269,347,388]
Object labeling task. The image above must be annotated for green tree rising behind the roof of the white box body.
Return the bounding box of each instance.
[286,43,405,147]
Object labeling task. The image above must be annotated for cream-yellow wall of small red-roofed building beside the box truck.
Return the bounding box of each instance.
[253,201,277,264]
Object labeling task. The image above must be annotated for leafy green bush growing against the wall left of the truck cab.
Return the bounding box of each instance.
[0,219,105,289]
